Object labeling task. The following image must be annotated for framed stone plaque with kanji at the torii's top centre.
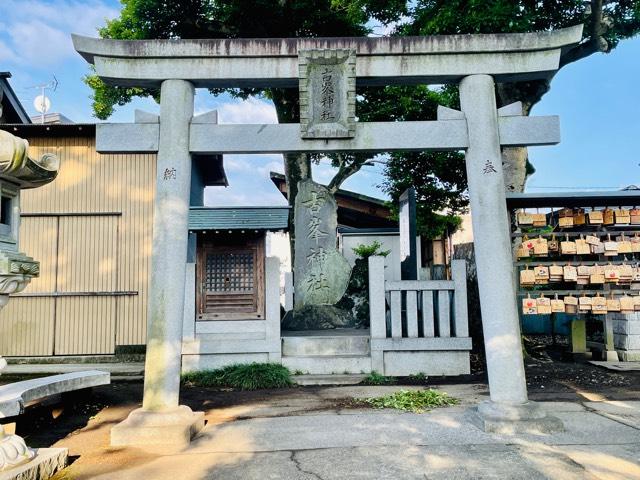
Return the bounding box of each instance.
[298,49,356,138]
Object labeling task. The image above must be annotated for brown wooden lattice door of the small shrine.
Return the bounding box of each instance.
[197,239,264,320]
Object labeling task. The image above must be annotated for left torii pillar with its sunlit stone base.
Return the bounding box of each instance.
[111,80,204,447]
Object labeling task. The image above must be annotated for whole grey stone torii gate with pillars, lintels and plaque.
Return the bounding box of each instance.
[73,26,582,445]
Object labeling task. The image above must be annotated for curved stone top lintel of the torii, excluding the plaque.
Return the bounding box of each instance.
[73,25,583,88]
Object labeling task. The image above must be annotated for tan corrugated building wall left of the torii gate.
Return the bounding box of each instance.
[0,136,155,356]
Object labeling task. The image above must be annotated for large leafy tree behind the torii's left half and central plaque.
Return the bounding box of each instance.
[86,0,407,256]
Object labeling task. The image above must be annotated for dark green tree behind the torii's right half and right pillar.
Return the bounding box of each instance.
[376,0,640,238]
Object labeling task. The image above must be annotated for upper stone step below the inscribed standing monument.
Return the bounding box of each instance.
[282,335,371,357]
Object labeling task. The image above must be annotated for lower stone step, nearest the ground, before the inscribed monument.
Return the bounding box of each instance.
[282,355,371,375]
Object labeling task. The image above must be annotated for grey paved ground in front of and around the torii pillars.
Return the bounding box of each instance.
[41,385,640,480]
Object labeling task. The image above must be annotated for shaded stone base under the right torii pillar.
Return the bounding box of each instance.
[470,400,564,434]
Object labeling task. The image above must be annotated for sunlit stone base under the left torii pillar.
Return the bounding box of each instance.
[111,405,204,450]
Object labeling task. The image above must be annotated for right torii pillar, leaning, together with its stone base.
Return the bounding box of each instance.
[460,75,559,431]
